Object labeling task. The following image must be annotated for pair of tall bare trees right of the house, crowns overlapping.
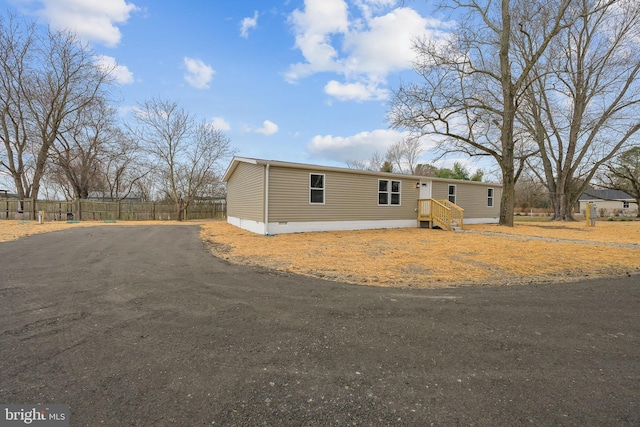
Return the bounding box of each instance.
[389,0,640,226]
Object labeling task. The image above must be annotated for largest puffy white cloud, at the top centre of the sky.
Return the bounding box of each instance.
[284,0,449,101]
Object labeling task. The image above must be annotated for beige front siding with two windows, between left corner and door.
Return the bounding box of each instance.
[269,166,419,222]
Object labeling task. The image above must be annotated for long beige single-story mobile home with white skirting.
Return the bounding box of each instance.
[223,157,502,234]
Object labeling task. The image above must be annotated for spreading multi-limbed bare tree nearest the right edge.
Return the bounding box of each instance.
[518,0,640,220]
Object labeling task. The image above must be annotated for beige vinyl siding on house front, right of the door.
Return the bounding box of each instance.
[432,181,502,218]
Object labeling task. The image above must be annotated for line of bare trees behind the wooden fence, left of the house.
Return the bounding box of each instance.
[0,14,235,219]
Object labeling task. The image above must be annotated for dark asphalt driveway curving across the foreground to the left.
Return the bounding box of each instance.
[0,223,640,426]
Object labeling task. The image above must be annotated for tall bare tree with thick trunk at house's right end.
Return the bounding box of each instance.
[389,0,574,226]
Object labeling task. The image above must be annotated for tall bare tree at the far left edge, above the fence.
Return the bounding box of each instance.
[0,15,111,215]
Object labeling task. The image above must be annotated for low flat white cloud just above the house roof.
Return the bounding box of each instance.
[307,129,408,163]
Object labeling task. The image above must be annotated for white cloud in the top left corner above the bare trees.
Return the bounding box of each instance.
[18,0,138,47]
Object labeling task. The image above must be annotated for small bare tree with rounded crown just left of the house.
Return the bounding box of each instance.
[130,99,235,221]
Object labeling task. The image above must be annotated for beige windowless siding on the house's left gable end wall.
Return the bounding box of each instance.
[227,162,265,222]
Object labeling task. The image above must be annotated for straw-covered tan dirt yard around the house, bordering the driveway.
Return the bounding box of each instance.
[0,221,640,287]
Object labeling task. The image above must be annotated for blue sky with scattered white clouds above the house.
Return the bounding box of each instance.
[0,0,484,172]
